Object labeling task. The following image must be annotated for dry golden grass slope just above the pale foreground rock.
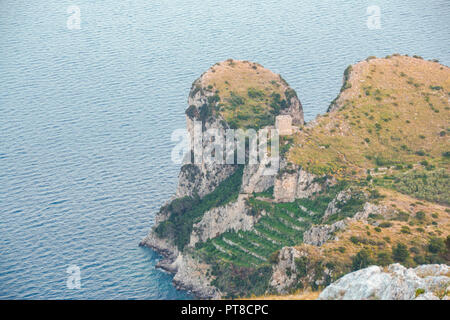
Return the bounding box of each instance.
[299,190,450,266]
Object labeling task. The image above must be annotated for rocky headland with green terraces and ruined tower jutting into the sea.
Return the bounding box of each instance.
[141,55,450,298]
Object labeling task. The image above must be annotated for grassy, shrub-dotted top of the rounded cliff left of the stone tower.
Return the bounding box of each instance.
[201,59,296,129]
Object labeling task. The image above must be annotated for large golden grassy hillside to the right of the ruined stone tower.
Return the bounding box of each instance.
[289,55,450,177]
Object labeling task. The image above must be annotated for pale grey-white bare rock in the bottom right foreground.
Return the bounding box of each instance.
[319,264,450,300]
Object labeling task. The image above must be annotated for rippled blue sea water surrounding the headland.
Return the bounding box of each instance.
[0,0,450,299]
